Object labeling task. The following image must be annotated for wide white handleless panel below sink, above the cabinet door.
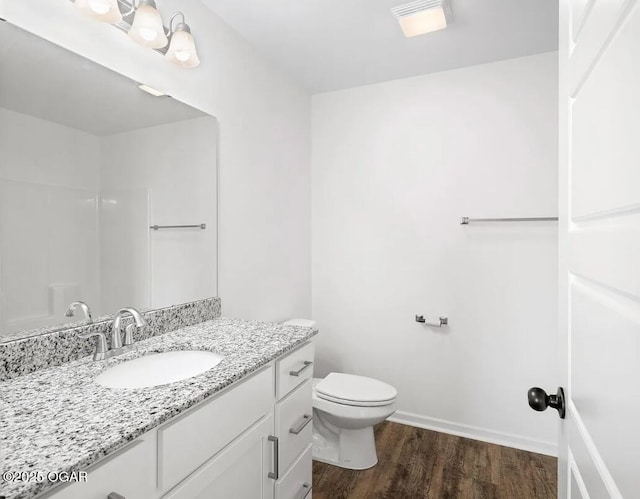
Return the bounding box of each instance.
[158,366,273,491]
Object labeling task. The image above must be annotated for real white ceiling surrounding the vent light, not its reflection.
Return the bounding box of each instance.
[202,0,558,93]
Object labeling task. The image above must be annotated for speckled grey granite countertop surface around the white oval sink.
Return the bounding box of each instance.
[0,317,317,499]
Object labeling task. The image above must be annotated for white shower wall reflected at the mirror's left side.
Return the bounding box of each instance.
[0,108,100,333]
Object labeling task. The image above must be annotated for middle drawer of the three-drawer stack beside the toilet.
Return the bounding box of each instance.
[275,380,313,472]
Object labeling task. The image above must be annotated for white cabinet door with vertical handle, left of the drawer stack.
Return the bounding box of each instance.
[163,414,274,499]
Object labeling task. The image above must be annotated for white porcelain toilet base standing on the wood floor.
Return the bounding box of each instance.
[312,421,378,470]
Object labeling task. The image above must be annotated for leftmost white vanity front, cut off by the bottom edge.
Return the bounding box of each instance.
[38,432,156,499]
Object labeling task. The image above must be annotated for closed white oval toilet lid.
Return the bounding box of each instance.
[315,373,398,405]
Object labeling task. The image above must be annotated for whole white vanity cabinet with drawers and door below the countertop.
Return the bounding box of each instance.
[40,342,314,499]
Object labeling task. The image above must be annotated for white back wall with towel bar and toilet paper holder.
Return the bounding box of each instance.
[312,53,558,453]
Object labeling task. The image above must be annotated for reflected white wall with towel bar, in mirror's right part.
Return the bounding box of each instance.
[100,116,218,310]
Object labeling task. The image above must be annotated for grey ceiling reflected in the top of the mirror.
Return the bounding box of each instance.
[0,22,206,135]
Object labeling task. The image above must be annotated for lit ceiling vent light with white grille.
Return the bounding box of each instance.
[391,0,451,38]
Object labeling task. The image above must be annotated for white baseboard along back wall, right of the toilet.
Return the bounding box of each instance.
[388,411,558,457]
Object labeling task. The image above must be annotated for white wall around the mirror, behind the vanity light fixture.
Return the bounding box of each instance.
[0,0,310,320]
